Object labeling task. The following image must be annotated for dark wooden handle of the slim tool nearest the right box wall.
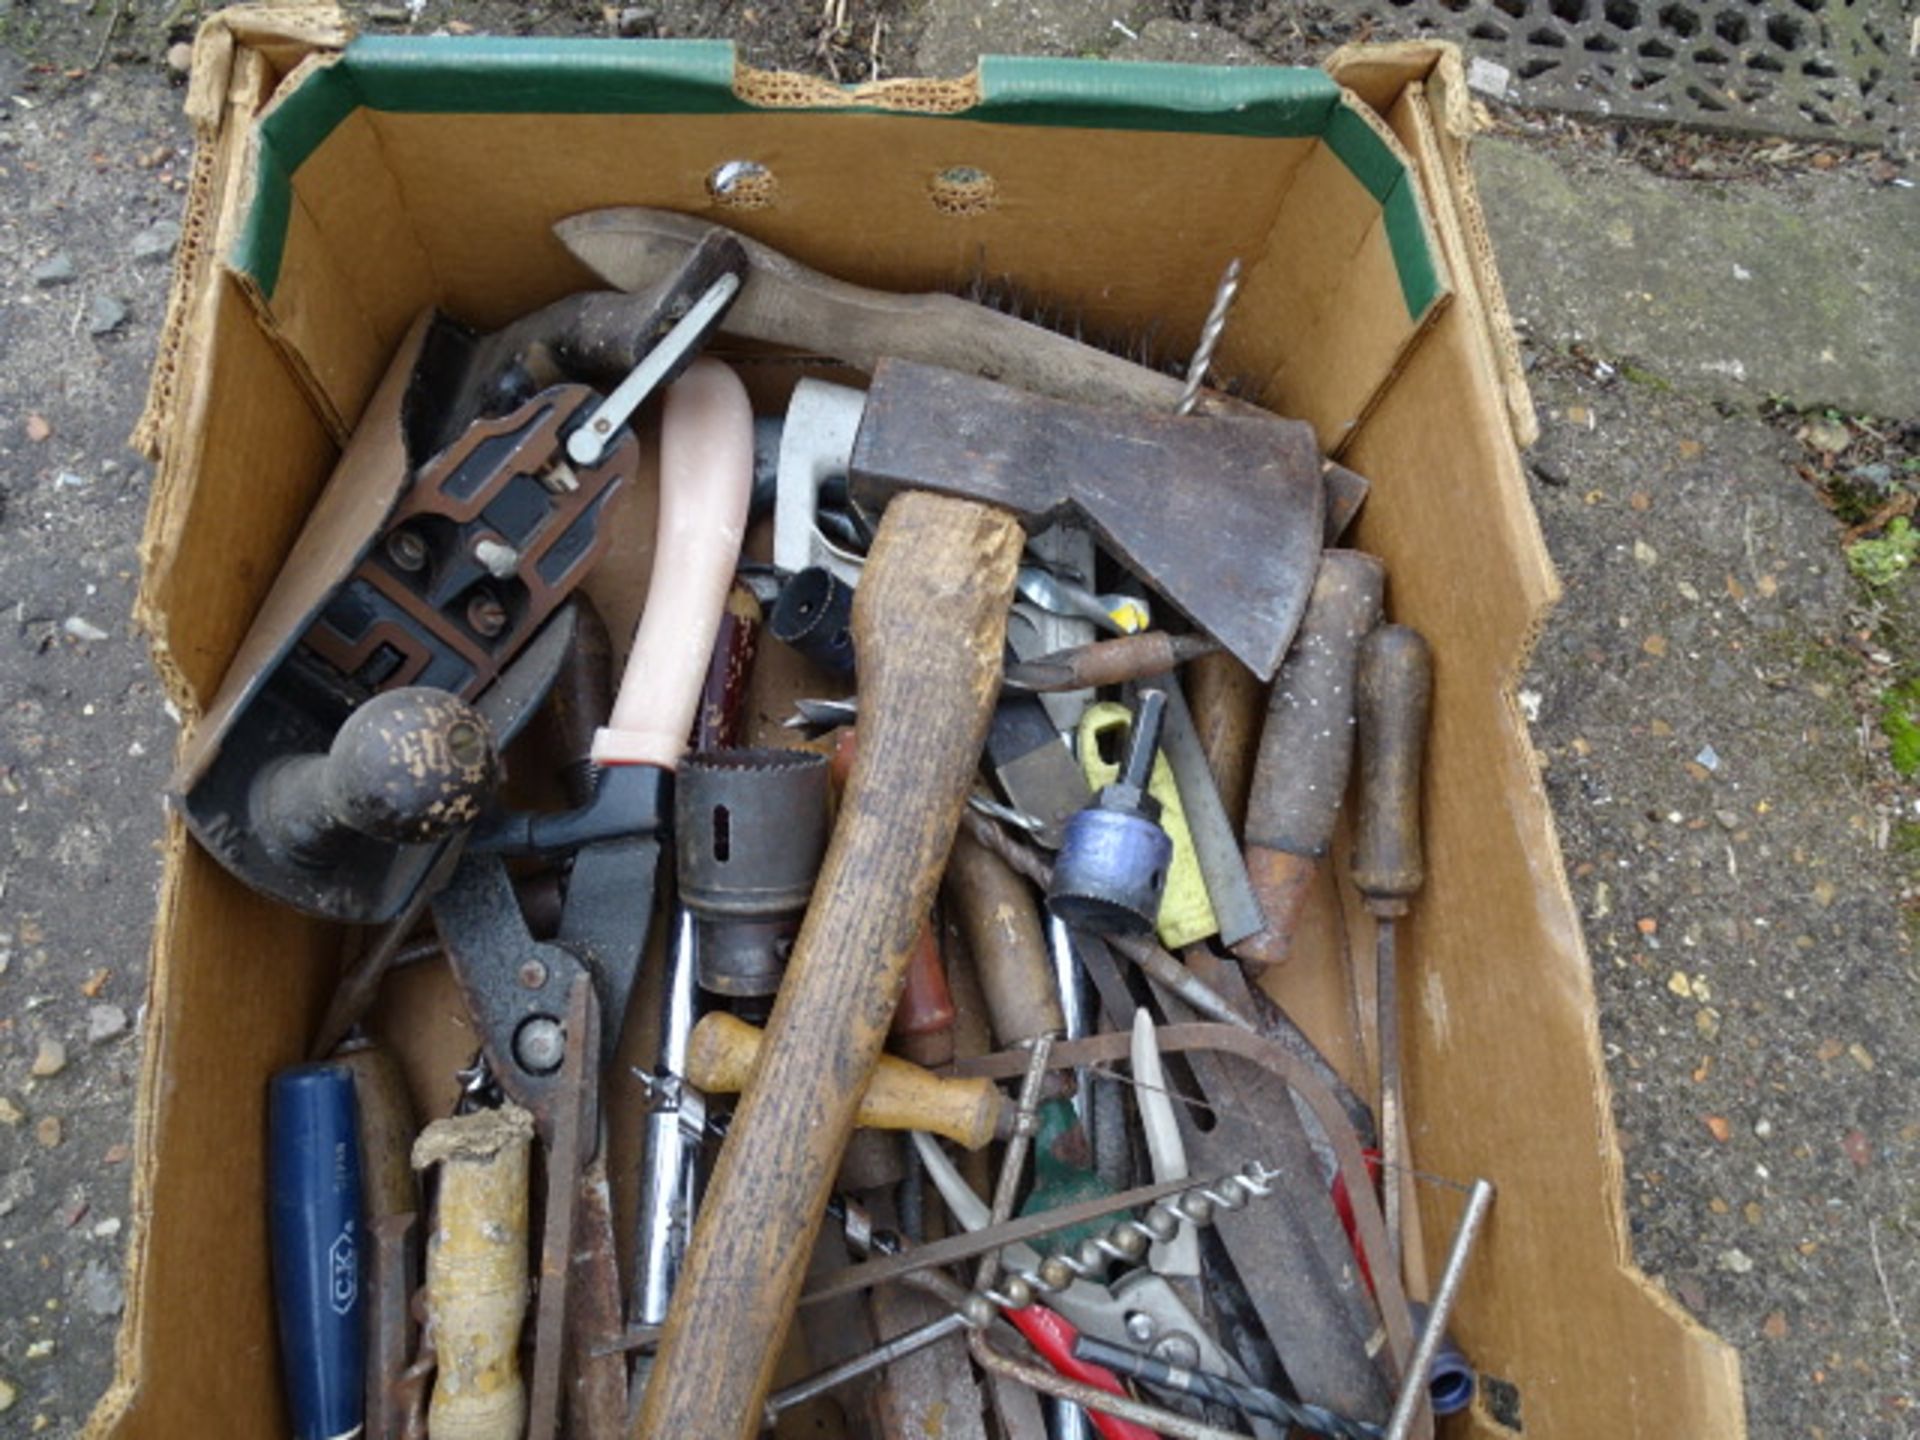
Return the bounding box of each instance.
[1352,626,1434,916]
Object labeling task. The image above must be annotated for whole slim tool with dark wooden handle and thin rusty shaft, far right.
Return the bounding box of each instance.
[1348,626,1432,1265]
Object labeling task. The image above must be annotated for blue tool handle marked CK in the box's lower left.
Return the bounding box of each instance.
[267,1066,367,1440]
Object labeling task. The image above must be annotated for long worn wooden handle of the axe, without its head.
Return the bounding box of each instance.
[632,493,1023,1440]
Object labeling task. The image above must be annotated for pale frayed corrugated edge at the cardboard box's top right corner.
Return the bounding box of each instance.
[1321,40,1540,449]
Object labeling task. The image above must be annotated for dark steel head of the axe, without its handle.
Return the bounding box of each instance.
[849,359,1325,680]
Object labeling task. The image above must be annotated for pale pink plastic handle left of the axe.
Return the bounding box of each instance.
[593,359,753,770]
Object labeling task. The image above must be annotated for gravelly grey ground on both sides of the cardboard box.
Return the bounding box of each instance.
[0,0,1920,1440]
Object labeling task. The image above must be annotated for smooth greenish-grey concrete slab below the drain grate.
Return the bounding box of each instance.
[1475,138,1920,415]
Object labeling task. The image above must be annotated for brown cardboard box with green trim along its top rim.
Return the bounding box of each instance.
[88,8,1743,1440]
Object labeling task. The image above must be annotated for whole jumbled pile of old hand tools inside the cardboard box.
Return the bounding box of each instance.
[175,209,1492,1440]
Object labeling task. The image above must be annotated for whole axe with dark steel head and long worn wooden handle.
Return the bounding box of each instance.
[634,361,1323,1440]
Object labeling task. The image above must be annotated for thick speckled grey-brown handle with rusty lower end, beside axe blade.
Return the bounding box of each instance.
[1235,549,1386,966]
